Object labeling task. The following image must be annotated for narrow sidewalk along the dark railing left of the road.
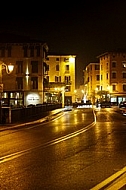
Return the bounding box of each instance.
[0,108,64,131]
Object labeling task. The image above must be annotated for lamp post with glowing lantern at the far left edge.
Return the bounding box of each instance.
[0,62,14,124]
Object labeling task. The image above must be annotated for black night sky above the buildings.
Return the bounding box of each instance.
[0,0,126,85]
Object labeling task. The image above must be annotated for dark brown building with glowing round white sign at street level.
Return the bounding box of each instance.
[0,36,48,107]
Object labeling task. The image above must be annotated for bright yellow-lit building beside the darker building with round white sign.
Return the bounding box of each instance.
[44,54,76,105]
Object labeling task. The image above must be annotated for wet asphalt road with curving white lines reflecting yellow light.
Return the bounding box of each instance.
[0,108,126,190]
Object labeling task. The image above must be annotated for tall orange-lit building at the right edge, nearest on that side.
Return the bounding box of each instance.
[98,51,126,105]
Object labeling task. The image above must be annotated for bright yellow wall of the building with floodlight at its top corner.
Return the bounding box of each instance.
[46,55,76,103]
